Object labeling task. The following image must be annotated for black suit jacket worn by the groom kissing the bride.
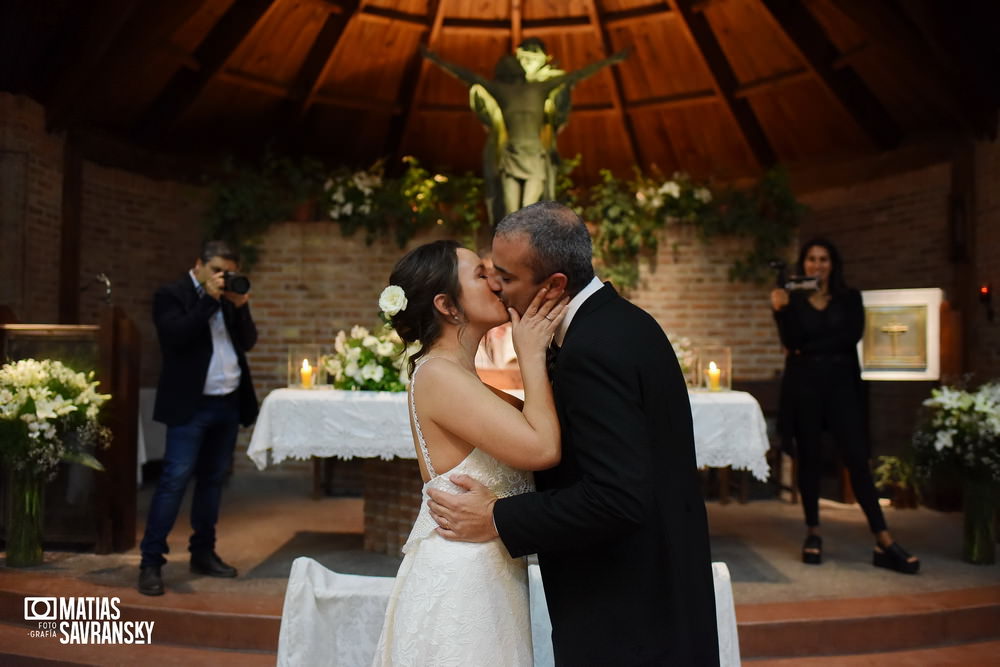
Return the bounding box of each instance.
[494,285,719,665]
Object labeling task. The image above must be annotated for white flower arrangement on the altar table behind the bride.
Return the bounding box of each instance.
[321,326,414,391]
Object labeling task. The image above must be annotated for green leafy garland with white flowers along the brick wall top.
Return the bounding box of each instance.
[206,154,804,290]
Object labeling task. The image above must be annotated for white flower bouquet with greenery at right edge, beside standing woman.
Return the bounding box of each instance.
[913,380,1000,482]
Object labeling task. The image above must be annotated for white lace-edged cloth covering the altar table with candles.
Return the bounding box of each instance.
[247,389,770,481]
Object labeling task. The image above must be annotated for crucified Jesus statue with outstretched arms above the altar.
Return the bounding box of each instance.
[423,40,627,223]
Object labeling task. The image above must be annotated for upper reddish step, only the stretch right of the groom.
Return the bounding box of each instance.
[736,586,1000,658]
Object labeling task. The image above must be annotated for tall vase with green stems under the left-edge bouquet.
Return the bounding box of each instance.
[4,470,45,567]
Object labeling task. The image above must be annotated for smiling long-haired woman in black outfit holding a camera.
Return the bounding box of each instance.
[771,239,920,574]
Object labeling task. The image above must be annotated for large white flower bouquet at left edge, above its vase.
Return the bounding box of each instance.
[0,359,111,476]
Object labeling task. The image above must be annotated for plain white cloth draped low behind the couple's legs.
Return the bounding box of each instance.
[278,557,740,667]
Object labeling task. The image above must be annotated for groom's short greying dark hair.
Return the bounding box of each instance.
[493,201,594,296]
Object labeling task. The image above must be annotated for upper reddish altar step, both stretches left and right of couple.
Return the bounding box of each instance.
[0,569,1000,664]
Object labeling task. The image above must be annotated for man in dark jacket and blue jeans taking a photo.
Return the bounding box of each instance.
[139,241,257,595]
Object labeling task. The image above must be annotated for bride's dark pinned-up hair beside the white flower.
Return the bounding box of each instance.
[389,241,462,371]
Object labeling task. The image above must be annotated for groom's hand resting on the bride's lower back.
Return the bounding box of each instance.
[427,475,497,542]
